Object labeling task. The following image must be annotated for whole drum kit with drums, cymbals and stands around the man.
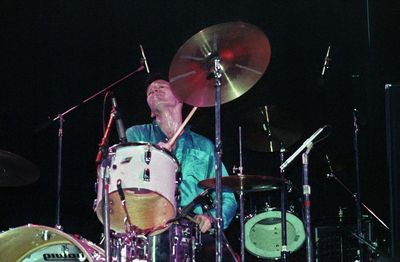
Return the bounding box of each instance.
[0,22,314,261]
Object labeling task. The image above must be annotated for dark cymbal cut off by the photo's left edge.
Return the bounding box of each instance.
[0,150,40,187]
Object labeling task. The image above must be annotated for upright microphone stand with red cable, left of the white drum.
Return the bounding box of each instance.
[96,107,116,262]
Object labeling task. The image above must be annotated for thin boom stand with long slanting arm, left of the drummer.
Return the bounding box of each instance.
[34,65,145,229]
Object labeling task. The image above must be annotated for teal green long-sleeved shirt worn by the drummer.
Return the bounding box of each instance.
[126,122,237,229]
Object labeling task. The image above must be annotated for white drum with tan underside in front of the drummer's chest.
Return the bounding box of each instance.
[95,143,180,235]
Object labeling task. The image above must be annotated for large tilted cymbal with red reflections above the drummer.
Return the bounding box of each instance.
[169,22,271,107]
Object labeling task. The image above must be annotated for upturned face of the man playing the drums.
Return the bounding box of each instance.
[146,79,180,115]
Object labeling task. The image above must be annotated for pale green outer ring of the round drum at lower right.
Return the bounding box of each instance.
[245,210,306,258]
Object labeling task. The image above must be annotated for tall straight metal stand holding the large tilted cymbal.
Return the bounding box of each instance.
[212,55,224,262]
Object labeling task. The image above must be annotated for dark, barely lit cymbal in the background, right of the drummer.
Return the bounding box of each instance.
[241,105,303,152]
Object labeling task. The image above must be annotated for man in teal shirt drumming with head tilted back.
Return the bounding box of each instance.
[126,74,237,233]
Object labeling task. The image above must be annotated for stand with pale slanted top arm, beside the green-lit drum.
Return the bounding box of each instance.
[279,125,329,262]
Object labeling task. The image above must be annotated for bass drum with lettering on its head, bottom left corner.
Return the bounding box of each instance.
[0,224,105,262]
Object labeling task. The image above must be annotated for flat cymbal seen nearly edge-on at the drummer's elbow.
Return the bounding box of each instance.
[198,175,288,192]
